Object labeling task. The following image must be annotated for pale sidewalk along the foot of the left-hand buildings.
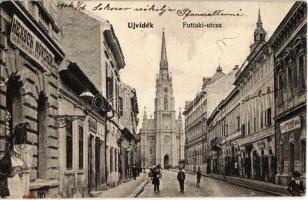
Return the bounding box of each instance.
[98,173,148,198]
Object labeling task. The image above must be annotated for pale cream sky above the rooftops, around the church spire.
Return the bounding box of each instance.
[80,1,293,128]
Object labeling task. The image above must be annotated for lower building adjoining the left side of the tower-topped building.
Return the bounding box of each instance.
[207,88,243,176]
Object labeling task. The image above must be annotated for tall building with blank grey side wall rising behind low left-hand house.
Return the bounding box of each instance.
[59,7,125,190]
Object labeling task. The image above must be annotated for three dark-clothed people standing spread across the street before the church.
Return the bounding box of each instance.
[149,165,201,192]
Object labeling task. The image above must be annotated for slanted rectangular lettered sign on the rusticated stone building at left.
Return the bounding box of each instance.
[10,15,54,70]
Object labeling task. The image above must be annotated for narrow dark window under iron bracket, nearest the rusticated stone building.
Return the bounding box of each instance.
[66,122,73,169]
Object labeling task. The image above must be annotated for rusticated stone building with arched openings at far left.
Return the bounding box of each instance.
[0,1,64,198]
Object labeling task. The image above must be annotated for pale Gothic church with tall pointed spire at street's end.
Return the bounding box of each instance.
[140,32,184,169]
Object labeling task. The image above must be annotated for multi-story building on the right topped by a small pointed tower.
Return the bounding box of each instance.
[234,10,276,181]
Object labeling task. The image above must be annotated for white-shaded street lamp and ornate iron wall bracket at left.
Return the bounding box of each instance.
[53,90,94,128]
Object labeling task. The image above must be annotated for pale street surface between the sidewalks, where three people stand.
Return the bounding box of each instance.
[138,170,270,197]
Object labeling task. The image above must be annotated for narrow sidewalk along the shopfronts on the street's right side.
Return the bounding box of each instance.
[203,174,290,196]
